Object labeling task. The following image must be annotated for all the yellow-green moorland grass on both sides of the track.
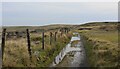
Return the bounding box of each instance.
[3,22,120,67]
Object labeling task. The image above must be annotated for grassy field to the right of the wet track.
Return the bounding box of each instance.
[79,25,119,67]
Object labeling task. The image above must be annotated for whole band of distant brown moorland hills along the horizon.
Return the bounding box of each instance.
[3,22,118,31]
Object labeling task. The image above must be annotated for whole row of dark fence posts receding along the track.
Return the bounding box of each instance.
[1,29,70,60]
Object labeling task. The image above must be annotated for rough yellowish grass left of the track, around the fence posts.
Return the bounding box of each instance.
[3,32,72,67]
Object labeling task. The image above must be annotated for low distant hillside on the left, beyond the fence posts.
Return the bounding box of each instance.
[3,24,75,31]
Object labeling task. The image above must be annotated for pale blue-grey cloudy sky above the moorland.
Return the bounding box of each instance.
[0,2,118,26]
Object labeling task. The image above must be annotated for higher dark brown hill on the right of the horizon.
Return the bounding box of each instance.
[75,22,118,30]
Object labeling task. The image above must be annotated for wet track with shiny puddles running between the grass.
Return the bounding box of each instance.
[50,33,86,67]
